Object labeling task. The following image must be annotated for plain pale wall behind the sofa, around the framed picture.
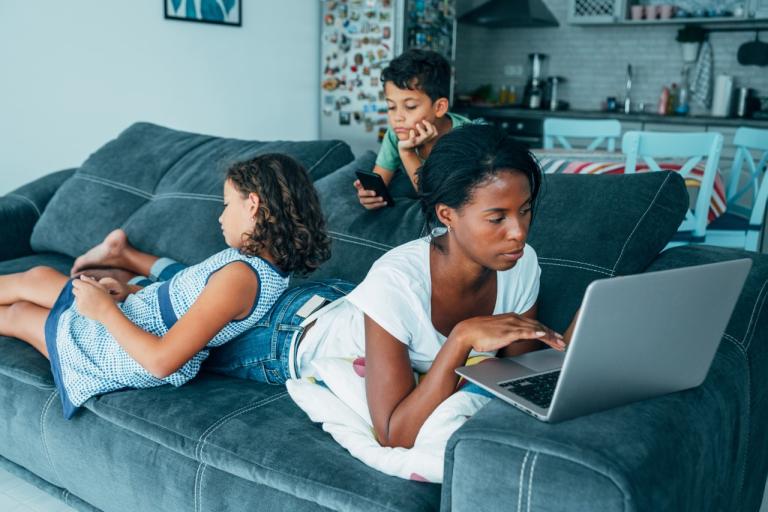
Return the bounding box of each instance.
[0,0,320,195]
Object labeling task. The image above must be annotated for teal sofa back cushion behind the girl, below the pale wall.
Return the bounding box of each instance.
[31,123,354,264]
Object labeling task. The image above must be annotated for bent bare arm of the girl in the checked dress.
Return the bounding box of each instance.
[73,262,259,379]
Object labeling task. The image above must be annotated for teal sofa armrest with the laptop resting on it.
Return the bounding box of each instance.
[442,246,768,512]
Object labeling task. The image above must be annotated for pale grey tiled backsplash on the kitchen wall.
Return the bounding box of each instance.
[456,0,768,114]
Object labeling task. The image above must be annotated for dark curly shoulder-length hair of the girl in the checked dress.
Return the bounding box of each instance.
[227,153,331,274]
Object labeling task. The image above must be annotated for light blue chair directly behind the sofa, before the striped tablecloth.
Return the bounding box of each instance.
[621,131,723,247]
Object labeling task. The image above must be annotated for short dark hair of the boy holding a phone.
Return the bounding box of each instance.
[381,48,451,101]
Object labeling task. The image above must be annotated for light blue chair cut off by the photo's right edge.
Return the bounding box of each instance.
[707,128,768,251]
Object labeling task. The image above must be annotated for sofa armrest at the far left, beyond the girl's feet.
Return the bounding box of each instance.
[0,169,75,261]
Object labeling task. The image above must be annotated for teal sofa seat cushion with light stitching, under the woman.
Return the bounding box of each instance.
[86,373,440,510]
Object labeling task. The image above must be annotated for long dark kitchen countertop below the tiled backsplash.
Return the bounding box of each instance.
[452,105,768,128]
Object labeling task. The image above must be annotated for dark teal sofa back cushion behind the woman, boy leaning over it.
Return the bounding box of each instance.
[310,168,689,330]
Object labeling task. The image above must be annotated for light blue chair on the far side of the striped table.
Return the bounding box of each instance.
[544,117,621,151]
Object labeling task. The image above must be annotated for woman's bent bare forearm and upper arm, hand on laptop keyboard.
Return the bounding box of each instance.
[365,313,564,448]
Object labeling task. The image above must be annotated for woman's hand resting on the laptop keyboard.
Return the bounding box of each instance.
[451,313,565,352]
